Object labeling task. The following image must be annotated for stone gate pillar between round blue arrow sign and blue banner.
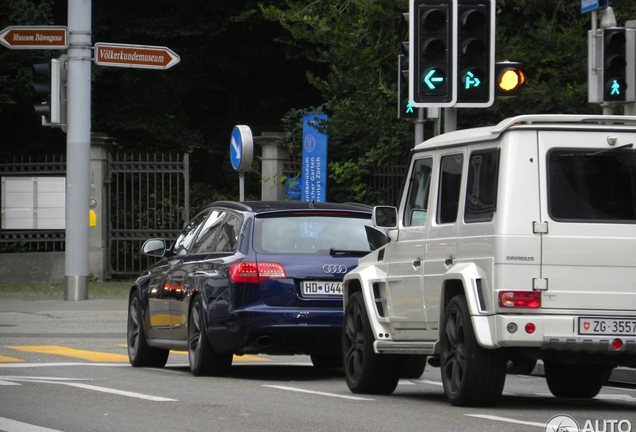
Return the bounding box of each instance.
[254,132,288,201]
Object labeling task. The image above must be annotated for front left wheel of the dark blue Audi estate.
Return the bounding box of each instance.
[126,291,170,368]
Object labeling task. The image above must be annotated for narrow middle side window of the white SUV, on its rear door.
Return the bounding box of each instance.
[437,154,464,224]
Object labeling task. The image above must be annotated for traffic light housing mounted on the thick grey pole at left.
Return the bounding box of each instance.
[33,56,66,127]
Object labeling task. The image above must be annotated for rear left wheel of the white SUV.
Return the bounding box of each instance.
[440,296,506,407]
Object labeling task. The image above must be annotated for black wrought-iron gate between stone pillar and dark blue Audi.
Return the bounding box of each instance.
[107,154,190,276]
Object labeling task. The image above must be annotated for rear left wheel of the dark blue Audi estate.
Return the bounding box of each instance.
[188,296,232,376]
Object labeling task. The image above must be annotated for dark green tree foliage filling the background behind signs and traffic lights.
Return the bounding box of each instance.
[0,0,636,201]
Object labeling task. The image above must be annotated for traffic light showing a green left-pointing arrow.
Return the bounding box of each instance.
[409,0,457,107]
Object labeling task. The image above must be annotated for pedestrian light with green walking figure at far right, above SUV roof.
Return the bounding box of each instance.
[588,27,636,103]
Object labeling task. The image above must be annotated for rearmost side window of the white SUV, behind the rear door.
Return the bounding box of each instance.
[464,149,499,223]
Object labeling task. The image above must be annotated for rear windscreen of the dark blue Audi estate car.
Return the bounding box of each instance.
[254,215,387,255]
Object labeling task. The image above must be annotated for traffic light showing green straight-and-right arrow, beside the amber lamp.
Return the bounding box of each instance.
[455,0,495,108]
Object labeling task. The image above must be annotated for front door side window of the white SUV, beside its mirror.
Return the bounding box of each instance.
[403,158,433,226]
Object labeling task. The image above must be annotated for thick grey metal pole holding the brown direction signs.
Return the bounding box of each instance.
[64,0,93,300]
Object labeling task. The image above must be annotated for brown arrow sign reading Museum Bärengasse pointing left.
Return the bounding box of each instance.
[0,26,68,49]
